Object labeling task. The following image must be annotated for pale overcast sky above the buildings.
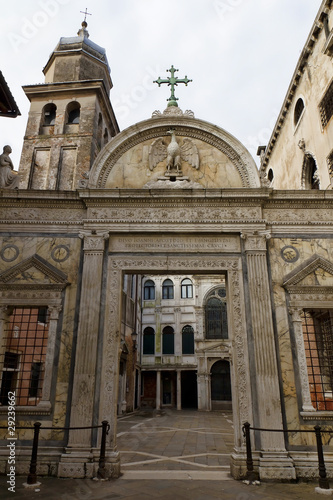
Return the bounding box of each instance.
[0,0,321,168]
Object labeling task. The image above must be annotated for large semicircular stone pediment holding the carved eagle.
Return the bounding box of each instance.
[88,116,260,190]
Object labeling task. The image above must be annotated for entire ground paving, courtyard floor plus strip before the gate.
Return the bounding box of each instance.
[0,410,326,500]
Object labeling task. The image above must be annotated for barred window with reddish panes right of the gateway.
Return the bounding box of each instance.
[302,309,333,411]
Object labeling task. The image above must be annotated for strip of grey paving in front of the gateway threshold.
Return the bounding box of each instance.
[0,471,330,500]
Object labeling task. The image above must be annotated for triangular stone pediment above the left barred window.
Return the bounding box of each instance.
[0,254,68,288]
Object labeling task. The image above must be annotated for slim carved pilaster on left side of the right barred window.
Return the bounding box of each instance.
[289,307,316,412]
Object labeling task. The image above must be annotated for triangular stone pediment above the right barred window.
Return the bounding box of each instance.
[283,255,333,290]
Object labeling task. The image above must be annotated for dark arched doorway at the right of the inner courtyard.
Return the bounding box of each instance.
[211,359,232,410]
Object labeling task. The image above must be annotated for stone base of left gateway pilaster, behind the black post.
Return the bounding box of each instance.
[58,448,120,479]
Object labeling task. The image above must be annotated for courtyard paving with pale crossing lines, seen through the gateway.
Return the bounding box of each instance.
[117,410,233,471]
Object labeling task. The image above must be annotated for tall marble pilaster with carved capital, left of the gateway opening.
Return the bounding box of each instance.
[68,232,108,448]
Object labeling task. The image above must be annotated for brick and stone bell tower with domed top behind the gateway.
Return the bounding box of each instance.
[19,21,119,190]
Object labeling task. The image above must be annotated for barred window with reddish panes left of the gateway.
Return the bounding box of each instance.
[0,307,49,406]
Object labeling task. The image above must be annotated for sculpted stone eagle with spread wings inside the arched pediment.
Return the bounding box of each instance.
[149,130,199,172]
